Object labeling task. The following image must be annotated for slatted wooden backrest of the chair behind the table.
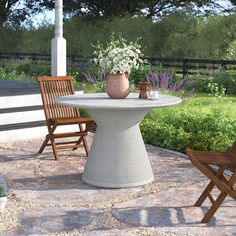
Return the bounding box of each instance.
[38,76,79,120]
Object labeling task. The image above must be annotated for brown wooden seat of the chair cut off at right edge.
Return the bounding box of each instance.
[193,151,236,166]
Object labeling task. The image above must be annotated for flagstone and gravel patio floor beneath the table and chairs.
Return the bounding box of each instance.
[0,136,236,236]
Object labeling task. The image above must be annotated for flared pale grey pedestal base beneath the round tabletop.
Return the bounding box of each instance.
[82,109,154,188]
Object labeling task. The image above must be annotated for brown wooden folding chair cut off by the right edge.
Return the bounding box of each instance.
[185,142,236,223]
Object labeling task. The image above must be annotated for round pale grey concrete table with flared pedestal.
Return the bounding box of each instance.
[57,93,181,188]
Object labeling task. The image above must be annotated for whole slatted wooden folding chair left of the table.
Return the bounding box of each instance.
[38,76,94,160]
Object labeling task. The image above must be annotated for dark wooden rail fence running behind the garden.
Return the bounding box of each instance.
[0,52,236,77]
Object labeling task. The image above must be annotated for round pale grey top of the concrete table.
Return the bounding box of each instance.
[57,93,182,110]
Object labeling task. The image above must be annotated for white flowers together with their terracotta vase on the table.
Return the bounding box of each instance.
[93,34,143,98]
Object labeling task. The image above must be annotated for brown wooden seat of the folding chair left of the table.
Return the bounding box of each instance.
[48,117,93,125]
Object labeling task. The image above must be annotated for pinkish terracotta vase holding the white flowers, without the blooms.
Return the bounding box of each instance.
[106,73,129,99]
